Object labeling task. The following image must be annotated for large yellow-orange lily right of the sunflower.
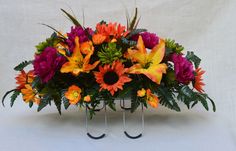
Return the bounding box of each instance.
[126,36,167,84]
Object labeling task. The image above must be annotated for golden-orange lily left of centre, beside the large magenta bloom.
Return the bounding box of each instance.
[59,37,99,76]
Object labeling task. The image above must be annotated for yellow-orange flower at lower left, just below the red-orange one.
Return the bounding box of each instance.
[21,84,40,104]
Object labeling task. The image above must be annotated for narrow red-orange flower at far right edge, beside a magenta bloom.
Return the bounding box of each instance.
[193,68,205,93]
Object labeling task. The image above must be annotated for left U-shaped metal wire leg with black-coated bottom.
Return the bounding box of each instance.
[86,102,107,139]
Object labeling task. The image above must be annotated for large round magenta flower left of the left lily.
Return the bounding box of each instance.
[33,47,66,83]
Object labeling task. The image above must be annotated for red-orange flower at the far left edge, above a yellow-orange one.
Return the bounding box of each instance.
[15,70,35,90]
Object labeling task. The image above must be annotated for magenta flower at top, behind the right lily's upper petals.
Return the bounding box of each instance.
[132,32,159,49]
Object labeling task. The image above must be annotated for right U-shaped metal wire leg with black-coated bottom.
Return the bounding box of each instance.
[122,99,144,139]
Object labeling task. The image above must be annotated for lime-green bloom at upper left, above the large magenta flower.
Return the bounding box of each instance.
[35,33,60,54]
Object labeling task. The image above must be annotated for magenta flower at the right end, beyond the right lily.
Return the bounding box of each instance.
[171,54,194,84]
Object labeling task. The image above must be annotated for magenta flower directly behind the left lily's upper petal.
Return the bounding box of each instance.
[66,26,93,51]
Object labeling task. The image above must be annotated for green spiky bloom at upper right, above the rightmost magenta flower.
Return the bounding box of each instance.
[165,39,184,56]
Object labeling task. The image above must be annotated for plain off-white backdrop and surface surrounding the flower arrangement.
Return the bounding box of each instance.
[0,0,236,151]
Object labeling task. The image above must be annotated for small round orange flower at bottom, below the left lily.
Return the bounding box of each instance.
[65,85,81,105]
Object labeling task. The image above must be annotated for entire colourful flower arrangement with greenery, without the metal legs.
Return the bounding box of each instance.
[2,9,216,117]
